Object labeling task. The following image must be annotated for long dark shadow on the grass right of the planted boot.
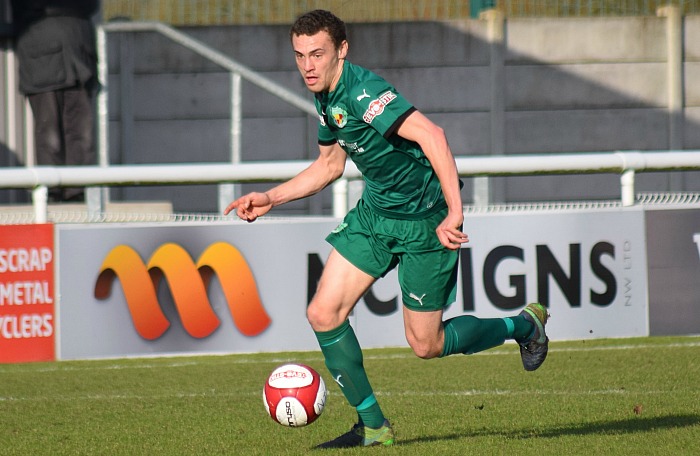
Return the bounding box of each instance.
[397,414,700,445]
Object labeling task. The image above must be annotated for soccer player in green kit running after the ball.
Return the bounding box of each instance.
[224,10,549,448]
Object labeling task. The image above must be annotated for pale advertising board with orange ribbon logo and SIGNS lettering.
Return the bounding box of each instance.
[56,209,648,359]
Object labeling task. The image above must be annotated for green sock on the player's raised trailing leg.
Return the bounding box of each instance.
[440,315,533,357]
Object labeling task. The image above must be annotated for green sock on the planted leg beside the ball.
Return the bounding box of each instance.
[315,320,384,428]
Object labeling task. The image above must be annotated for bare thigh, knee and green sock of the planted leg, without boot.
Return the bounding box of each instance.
[307,250,385,438]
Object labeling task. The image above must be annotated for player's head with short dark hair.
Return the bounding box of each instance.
[289,10,348,93]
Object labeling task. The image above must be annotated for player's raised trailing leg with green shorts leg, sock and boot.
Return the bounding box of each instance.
[399,213,547,370]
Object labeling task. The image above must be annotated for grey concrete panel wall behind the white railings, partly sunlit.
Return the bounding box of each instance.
[0,11,700,214]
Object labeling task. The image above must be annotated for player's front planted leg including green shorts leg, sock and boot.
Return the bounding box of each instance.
[308,199,395,448]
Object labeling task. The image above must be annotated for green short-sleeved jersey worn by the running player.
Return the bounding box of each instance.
[315,60,446,220]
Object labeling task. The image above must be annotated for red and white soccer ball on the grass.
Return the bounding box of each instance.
[263,364,328,427]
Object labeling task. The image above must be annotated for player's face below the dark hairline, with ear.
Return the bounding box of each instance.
[292,31,348,93]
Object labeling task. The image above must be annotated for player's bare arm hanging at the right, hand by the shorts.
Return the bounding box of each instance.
[397,111,469,250]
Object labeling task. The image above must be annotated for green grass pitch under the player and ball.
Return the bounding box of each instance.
[0,337,700,456]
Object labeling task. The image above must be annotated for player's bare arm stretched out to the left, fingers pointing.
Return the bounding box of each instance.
[224,143,347,222]
